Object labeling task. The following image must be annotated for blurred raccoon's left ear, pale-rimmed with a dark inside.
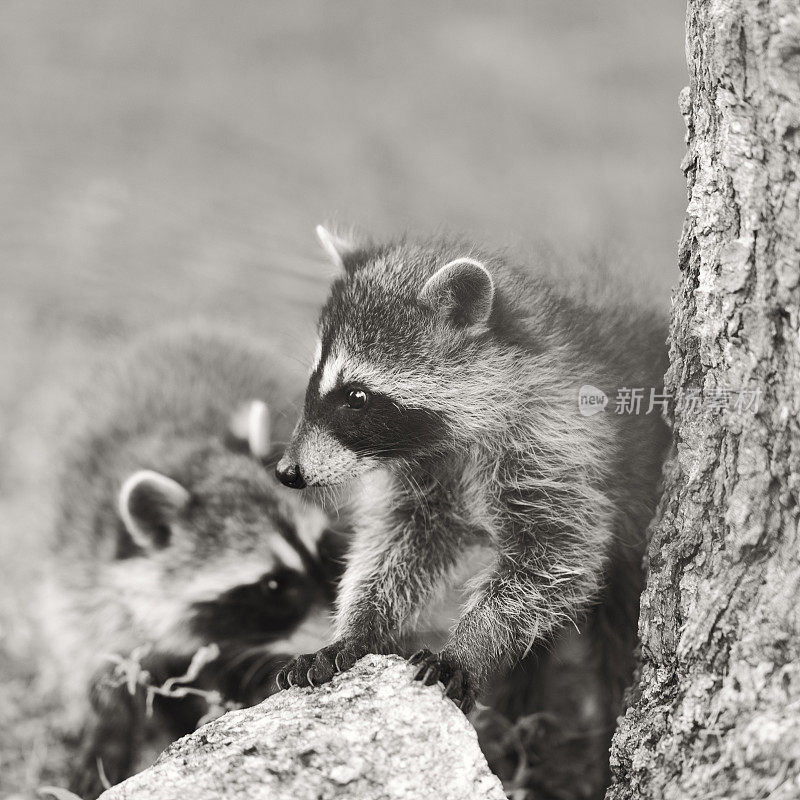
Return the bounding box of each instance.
[119,469,190,550]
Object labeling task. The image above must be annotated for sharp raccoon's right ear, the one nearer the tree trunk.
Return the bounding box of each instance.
[419,257,494,325]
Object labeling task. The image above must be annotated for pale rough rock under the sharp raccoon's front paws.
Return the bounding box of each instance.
[97,655,505,800]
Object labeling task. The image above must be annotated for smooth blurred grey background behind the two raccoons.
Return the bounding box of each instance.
[0,0,686,796]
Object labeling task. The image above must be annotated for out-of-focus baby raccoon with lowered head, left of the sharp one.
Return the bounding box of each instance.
[44,329,336,797]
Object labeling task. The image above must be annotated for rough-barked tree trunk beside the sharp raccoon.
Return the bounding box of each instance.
[608,0,800,800]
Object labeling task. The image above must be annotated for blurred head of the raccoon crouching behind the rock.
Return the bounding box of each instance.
[115,454,333,653]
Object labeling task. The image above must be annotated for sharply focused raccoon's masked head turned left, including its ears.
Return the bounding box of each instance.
[276,228,494,488]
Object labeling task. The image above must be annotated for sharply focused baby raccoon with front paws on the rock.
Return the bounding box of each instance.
[277,228,669,752]
